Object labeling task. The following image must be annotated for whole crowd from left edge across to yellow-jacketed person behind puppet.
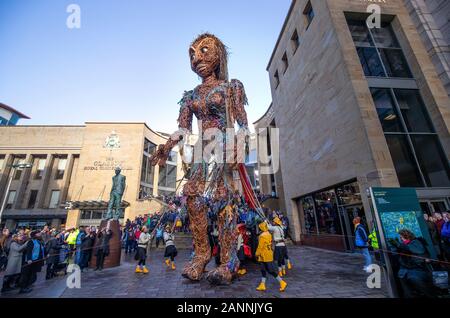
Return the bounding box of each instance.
[0,189,292,293]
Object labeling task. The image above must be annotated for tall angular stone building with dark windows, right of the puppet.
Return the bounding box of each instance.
[262,0,450,250]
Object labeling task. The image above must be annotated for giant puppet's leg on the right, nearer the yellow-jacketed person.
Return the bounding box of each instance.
[207,174,239,285]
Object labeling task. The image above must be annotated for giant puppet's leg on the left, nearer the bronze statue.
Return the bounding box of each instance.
[182,168,211,281]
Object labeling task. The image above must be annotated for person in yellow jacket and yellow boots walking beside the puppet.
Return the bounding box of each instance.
[255,222,287,292]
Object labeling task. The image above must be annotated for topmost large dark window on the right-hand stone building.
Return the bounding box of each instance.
[347,19,412,78]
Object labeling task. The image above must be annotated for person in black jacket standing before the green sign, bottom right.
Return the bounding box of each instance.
[389,229,435,298]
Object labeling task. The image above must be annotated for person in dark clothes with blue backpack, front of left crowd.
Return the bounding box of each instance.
[19,231,45,294]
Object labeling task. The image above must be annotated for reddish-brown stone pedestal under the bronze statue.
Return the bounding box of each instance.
[90,220,122,268]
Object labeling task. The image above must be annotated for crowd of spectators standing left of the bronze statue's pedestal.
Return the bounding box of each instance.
[0,226,112,293]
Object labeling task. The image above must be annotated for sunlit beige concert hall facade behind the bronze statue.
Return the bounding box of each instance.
[0,122,183,228]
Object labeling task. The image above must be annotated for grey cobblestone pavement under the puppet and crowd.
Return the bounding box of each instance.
[1,246,387,298]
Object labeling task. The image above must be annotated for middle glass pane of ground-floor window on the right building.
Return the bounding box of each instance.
[314,190,342,234]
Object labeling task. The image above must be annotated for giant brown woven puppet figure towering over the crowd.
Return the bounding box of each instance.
[152,33,248,284]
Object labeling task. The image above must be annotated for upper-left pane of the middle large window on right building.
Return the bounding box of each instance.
[370,88,404,132]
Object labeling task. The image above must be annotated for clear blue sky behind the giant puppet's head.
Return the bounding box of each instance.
[0,0,291,132]
